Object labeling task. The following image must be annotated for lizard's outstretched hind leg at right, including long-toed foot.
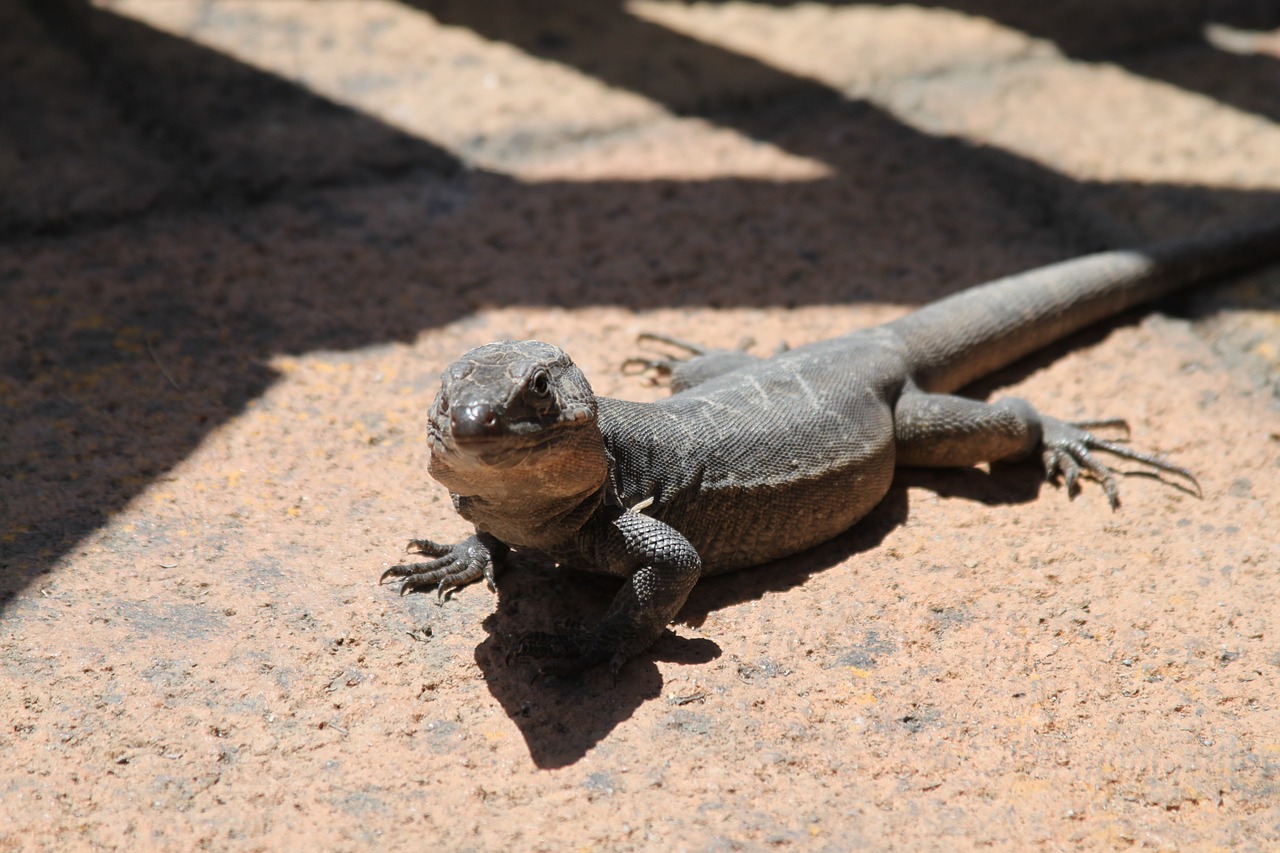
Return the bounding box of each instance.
[893,388,1199,508]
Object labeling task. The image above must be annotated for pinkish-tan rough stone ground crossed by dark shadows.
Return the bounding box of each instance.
[0,0,1280,850]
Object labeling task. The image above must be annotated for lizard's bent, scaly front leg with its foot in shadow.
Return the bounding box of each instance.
[512,510,701,675]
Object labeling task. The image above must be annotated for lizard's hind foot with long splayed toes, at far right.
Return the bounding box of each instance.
[1042,418,1202,510]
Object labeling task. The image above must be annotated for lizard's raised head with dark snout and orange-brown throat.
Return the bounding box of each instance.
[429,341,608,503]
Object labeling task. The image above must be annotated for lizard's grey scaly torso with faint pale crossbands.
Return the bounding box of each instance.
[600,333,901,574]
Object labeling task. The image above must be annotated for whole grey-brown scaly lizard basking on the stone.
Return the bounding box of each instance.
[379,222,1280,676]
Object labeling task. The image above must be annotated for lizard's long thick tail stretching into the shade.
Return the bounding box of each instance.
[888,220,1280,393]
